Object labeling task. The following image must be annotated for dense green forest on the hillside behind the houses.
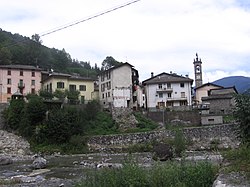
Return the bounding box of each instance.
[0,29,121,78]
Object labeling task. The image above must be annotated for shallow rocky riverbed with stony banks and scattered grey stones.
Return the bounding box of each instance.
[0,130,250,187]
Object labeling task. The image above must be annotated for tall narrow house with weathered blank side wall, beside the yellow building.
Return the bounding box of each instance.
[98,62,139,108]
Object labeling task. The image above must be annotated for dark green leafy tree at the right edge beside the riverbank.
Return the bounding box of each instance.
[234,94,250,145]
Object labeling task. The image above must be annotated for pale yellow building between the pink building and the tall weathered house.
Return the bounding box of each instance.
[42,72,97,103]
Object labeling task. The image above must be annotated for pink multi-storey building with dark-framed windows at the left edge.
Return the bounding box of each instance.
[0,65,41,103]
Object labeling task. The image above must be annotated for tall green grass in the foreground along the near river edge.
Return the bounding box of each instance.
[76,159,218,187]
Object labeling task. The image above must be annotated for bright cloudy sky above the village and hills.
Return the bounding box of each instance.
[0,0,250,83]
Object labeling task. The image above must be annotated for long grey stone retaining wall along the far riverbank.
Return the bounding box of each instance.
[88,124,240,151]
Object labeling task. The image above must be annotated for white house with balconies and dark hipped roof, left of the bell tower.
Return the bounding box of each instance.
[142,72,193,110]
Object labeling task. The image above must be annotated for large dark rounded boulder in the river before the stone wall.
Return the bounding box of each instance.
[153,143,173,161]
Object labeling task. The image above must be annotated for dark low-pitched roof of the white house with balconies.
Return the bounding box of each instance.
[142,72,193,84]
